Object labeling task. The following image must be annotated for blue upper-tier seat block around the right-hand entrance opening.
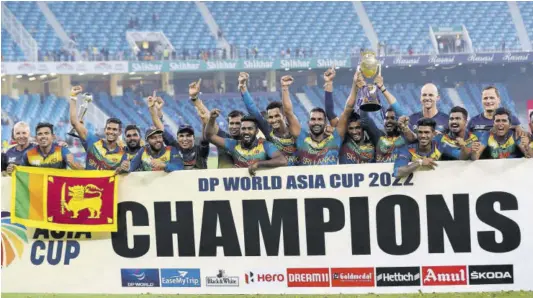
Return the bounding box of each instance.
[364,1,520,53]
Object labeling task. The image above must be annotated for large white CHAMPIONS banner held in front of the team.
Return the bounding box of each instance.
[2,159,533,294]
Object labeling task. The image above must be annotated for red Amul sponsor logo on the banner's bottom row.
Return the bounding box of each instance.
[422,266,466,286]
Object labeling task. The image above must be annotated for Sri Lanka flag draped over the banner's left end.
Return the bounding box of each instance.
[11,167,118,232]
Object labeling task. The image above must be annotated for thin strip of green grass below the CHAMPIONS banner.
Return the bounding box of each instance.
[2,291,533,298]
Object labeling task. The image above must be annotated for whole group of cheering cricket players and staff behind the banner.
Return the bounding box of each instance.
[2,68,533,177]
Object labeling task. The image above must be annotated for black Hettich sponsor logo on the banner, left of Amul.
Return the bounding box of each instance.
[376,267,420,287]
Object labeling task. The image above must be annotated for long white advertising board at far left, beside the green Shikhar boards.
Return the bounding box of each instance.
[2,61,128,75]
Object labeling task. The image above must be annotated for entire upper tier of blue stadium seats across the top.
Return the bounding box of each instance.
[2,1,533,61]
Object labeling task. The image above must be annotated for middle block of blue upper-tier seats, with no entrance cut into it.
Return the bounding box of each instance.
[206,1,370,57]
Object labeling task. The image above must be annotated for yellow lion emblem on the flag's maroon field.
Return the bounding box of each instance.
[61,183,102,218]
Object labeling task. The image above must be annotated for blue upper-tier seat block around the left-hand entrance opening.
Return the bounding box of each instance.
[48,1,216,54]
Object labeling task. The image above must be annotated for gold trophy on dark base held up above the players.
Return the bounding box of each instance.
[357,51,381,112]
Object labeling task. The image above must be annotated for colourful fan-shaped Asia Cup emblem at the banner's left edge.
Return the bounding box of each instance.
[2,211,28,268]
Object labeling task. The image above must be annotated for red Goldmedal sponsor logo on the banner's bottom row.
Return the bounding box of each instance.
[331,268,374,287]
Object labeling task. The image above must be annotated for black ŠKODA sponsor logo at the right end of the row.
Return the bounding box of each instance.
[468,265,514,285]
